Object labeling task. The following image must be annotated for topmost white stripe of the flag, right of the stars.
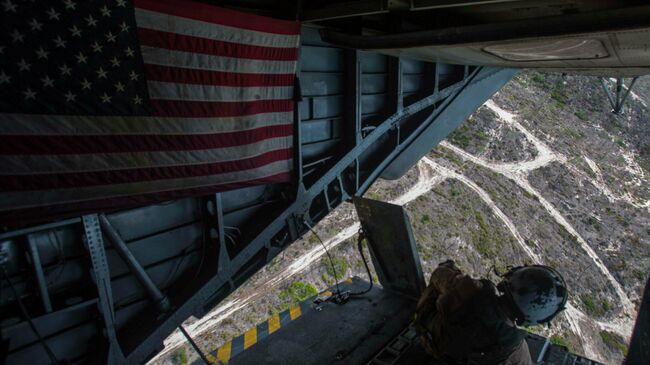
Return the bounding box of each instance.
[135,8,300,48]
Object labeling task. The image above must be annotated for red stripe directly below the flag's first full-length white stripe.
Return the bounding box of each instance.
[0,124,293,155]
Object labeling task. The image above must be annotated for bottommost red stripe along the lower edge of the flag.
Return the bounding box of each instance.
[0,172,291,228]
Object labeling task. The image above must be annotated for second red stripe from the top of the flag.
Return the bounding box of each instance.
[138,28,298,61]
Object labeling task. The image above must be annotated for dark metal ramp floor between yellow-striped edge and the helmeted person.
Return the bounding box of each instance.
[229,278,416,365]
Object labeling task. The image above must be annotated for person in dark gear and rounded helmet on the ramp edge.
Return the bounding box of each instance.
[414,260,567,365]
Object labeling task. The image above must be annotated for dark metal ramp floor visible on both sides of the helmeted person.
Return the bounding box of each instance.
[224,277,602,365]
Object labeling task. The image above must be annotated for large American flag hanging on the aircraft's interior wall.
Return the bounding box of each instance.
[0,0,300,223]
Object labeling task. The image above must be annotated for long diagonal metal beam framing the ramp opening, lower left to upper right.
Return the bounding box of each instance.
[128,68,512,363]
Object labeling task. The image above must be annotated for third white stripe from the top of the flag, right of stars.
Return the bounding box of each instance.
[147,81,293,101]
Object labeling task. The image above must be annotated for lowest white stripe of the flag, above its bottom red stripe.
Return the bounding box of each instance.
[0,159,292,211]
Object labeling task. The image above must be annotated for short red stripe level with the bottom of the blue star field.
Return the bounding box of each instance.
[150,99,294,118]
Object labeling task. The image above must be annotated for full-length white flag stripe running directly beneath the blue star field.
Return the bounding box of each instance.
[0,112,293,136]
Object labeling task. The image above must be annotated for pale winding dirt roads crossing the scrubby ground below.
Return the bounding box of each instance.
[152,100,632,361]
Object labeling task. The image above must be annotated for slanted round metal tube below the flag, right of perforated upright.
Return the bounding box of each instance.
[99,214,171,313]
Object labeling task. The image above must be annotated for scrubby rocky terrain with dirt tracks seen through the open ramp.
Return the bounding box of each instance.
[153,72,650,364]
